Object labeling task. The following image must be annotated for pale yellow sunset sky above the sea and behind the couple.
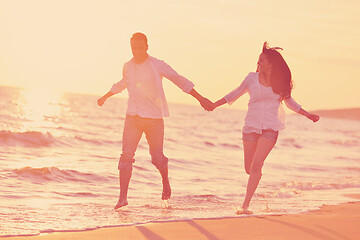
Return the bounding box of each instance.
[0,0,360,110]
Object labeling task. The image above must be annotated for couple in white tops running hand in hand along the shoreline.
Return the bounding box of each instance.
[97,32,319,214]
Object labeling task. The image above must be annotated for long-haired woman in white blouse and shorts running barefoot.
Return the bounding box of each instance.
[213,42,319,214]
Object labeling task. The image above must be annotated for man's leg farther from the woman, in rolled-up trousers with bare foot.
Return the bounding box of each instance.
[114,116,143,210]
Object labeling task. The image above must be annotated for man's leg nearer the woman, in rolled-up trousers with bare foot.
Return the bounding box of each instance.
[144,119,171,200]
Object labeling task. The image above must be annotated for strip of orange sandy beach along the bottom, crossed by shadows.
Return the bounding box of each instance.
[7,194,360,240]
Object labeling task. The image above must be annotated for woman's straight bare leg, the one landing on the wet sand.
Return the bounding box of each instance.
[243,137,275,210]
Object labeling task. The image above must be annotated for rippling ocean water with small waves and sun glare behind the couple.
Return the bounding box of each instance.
[0,87,360,236]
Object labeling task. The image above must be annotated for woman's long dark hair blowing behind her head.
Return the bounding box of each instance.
[262,42,293,100]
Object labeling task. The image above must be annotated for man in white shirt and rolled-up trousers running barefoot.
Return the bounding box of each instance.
[98,33,212,210]
